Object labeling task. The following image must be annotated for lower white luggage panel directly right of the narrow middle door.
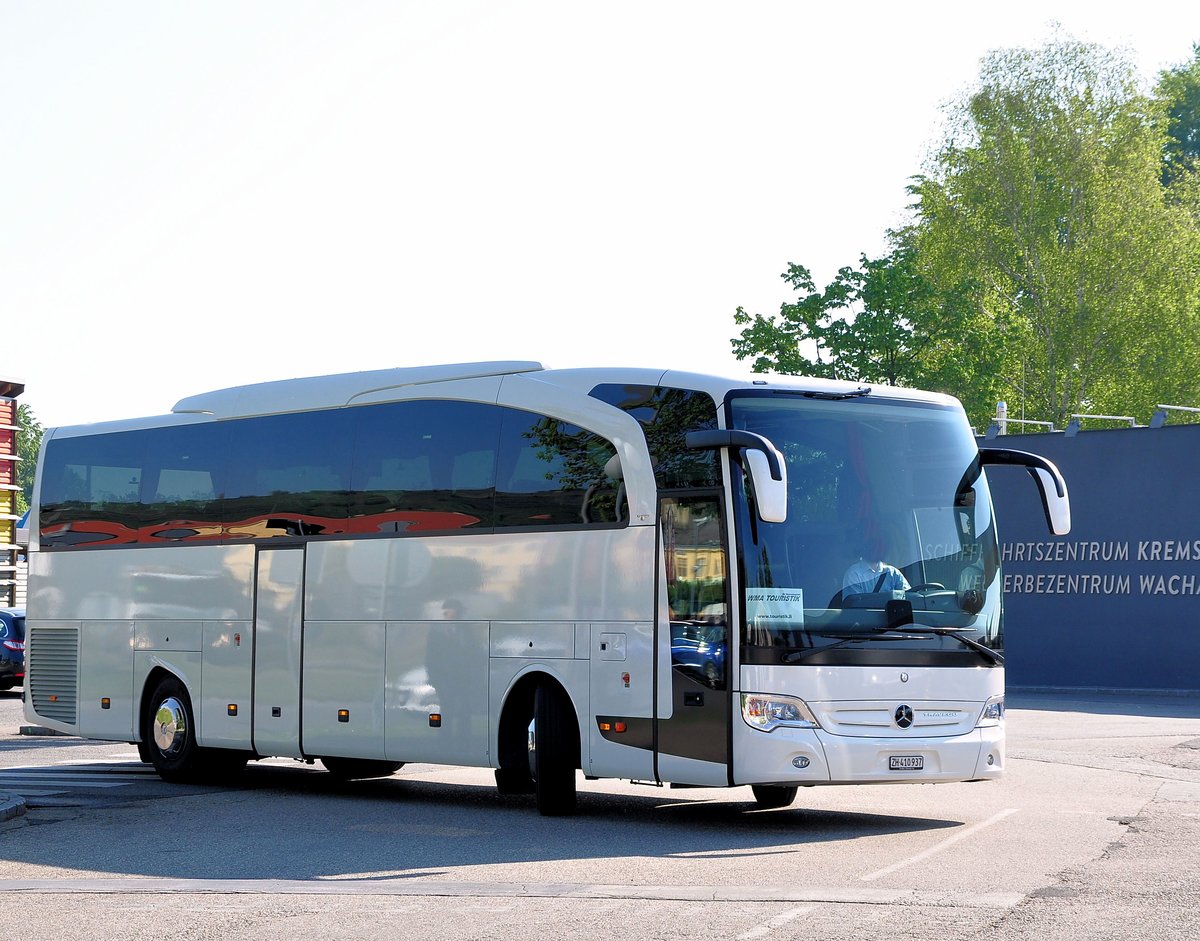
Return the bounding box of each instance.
[301,621,384,759]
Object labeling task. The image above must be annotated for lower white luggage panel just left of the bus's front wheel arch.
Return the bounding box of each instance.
[386,621,488,767]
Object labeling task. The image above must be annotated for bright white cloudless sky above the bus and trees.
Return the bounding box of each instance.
[0,0,1200,426]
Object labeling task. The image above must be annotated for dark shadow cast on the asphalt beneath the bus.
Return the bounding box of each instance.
[5,765,964,881]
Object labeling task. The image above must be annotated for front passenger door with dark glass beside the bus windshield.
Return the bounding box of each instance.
[656,491,731,786]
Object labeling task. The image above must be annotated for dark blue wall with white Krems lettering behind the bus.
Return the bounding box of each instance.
[980,425,1200,691]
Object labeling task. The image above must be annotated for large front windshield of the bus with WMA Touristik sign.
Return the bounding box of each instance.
[728,392,1002,664]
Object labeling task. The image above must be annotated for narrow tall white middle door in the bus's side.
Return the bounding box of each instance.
[252,547,305,757]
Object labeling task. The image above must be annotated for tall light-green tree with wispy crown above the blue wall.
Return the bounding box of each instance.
[912,40,1200,425]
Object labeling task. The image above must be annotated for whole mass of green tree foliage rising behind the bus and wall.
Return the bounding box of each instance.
[733,38,1200,427]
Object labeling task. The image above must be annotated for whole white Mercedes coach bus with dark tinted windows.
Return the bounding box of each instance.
[25,362,1069,814]
